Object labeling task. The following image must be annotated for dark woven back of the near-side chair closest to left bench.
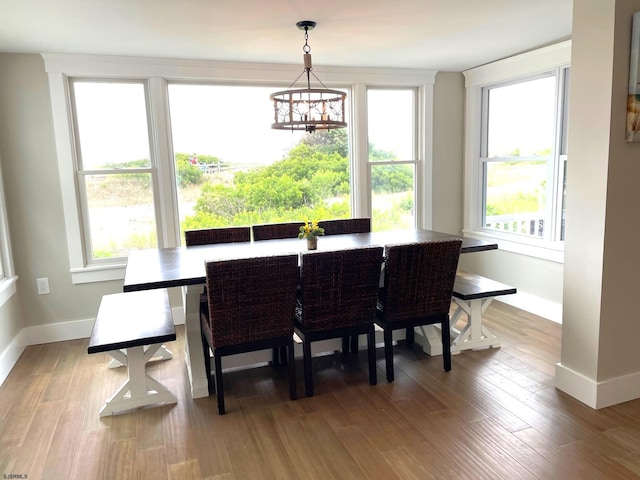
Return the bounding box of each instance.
[205,254,298,347]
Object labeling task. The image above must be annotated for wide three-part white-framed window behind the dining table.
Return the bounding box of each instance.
[43,54,435,283]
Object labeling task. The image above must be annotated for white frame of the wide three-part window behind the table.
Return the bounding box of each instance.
[42,54,436,283]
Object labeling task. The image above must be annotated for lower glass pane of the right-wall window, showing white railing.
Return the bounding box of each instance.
[485,160,548,237]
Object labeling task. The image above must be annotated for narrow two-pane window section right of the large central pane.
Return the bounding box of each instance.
[367,88,418,230]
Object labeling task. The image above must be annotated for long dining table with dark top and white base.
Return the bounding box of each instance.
[123,229,498,398]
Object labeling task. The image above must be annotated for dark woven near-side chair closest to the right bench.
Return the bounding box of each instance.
[376,239,462,382]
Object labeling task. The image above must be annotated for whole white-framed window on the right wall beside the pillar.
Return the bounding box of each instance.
[465,44,570,259]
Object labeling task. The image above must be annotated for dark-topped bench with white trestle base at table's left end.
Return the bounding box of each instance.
[87,289,177,417]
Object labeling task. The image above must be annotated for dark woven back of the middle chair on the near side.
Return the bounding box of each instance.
[300,247,383,332]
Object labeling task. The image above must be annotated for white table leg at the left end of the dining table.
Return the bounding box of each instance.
[182,285,209,398]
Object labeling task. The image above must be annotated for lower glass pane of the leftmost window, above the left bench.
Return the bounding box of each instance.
[84,173,158,259]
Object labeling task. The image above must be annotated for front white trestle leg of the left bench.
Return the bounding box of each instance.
[100,346,177,417]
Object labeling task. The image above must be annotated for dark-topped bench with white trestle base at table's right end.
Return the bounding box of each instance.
[451,271,517,353]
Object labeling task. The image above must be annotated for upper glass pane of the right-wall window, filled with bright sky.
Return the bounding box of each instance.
[488,76,556,158]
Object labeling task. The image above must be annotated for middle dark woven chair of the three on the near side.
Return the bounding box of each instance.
[295,246,383,397]
